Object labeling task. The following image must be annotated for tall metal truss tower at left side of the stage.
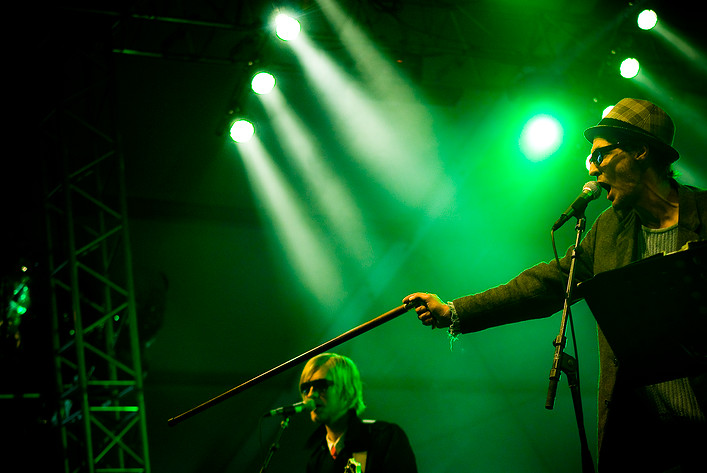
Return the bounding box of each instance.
[40,9,150,473]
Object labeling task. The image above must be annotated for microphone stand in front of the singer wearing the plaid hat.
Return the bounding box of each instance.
[545,216,595,473]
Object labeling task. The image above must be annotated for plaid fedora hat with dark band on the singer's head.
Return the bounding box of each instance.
[584,98,680,163]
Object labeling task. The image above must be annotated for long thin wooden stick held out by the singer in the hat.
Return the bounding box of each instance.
[167,305,408,427]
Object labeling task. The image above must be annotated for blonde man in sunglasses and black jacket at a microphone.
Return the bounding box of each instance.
[300,353,417,473]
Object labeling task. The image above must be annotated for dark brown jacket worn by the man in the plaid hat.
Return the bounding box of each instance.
[453,185,707,464]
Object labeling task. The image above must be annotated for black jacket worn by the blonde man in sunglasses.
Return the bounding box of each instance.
[307,410,417,473]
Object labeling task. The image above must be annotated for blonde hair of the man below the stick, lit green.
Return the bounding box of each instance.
[300,353,366,415]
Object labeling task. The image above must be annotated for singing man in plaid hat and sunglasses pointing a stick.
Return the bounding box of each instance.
[403,98,707,473]
